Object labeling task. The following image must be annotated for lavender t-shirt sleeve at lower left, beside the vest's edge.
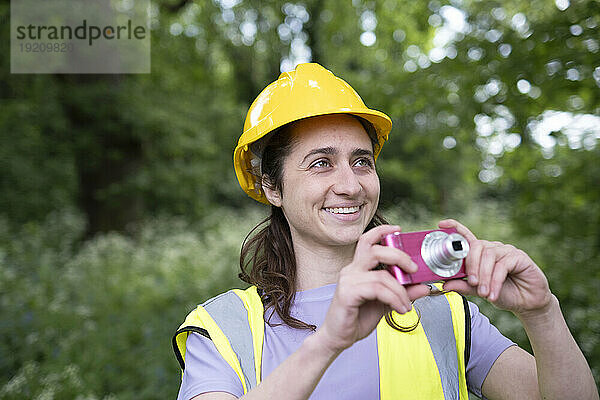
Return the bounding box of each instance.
[177,333,244,400]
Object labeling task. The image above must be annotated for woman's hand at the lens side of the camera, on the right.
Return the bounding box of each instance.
[439,219,552,314]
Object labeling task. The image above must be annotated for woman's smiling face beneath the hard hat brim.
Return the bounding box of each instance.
[265,114,379,247]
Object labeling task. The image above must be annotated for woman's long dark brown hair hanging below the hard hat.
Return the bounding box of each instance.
[239,117,419,332]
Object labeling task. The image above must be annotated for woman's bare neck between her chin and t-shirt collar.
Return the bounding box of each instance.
[294,241,356,291]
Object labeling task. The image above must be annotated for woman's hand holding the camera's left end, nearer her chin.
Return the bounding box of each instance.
[315,225,429,352]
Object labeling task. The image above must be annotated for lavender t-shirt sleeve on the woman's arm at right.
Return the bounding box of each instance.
[467,302,515,397]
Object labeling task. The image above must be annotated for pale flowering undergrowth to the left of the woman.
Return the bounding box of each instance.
[0,210,268,399]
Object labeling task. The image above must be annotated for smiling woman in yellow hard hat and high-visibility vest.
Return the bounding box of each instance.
[174,64,598,400]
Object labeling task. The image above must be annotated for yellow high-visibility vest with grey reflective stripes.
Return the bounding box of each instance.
[173,286,471,400]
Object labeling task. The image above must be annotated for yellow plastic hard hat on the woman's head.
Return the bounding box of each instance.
[233,63,392,204]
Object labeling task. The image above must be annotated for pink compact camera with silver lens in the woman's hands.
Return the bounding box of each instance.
[381,229,469,285]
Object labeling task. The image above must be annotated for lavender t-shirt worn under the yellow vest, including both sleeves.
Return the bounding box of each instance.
[177,284,514,400]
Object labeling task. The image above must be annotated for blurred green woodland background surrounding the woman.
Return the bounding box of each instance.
[0,0,600,400]
